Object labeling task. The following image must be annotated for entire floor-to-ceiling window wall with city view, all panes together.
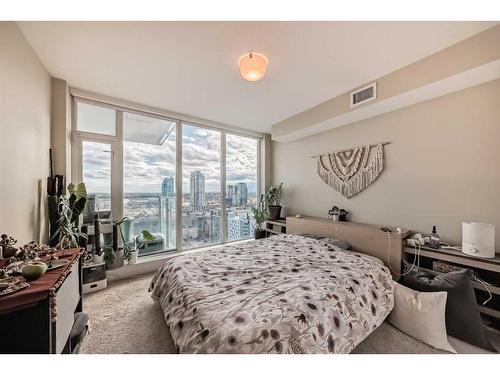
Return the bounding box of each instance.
[72,99,259,256]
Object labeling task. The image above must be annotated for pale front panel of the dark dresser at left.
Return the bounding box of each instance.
[56,262,80,353]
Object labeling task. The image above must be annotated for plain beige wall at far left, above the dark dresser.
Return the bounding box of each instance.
[0,22,51,244]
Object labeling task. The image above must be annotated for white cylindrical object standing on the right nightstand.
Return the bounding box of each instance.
[462,222,495,258]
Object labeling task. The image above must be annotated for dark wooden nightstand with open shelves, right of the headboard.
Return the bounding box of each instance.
[404,247,500,328]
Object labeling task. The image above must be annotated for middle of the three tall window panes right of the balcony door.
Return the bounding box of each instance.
[182,124,222,249]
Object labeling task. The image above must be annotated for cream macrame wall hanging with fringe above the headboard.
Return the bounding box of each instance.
[313,142,388,198]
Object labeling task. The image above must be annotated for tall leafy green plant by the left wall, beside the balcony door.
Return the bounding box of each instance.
[50,182,87,249]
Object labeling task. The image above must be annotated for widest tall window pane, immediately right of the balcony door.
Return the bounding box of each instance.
[123,112,176,256]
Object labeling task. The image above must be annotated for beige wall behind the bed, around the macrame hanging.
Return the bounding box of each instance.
[273,80,500,251]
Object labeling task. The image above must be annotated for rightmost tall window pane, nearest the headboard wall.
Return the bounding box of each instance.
[226,134,258,241]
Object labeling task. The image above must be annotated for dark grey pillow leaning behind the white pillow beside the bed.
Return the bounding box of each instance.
[402,269,496,352]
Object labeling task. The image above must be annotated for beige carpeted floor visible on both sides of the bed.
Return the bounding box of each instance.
[80,274,500,354]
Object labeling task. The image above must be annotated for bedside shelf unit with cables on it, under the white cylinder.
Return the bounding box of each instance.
[404,246,500,329]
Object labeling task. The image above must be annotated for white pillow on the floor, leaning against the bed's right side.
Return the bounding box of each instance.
[389,283,456,353]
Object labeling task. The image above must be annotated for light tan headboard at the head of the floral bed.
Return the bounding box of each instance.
[286,216,410,279]
